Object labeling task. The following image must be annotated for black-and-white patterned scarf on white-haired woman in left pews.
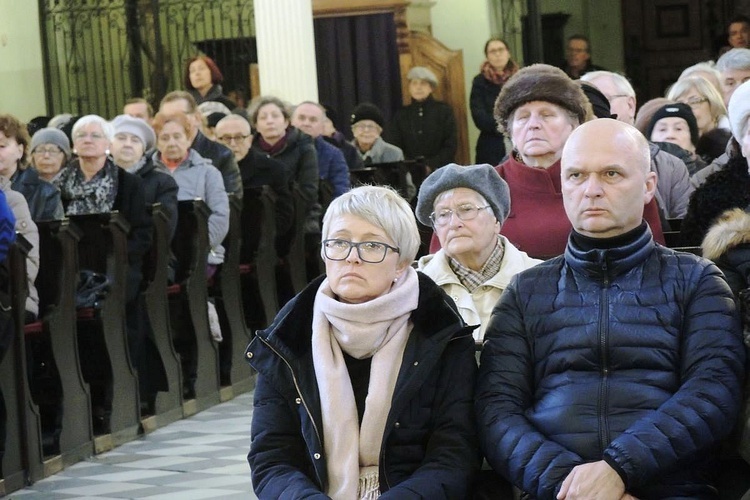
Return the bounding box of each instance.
[55,158,117,215]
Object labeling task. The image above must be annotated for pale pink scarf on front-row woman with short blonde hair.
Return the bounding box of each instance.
[312,267,419,500]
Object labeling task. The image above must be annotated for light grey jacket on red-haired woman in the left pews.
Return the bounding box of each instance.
[153,149,229,264]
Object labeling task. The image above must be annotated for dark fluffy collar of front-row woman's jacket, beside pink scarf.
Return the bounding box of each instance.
[258,273,463,358]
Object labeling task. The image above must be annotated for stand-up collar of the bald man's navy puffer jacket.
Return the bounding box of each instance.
[563,225,656,281]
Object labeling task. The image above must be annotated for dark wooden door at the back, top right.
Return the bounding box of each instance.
[622,0,735,103]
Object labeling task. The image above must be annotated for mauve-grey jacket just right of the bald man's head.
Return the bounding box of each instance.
[649,143,695,219]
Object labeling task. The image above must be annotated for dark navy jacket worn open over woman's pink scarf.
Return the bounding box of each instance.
[246,274,479,500]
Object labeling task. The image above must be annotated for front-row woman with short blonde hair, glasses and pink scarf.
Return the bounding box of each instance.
[246,186,479,499]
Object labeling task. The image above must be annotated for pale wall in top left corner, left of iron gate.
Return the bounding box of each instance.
[0,0,47,121]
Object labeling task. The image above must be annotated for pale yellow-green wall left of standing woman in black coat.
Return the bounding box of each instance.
[432,0,498,161]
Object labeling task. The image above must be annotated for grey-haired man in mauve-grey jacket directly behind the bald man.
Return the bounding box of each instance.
[581,71,695,218]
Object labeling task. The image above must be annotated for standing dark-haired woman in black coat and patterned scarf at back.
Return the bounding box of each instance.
[470,37,518,165]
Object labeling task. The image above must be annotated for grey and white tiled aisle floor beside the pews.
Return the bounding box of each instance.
[8,393,256,500]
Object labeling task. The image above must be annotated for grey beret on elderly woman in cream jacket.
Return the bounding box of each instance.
[416,163,510,226]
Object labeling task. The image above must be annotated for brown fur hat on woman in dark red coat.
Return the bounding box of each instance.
[495,64,591,131]
